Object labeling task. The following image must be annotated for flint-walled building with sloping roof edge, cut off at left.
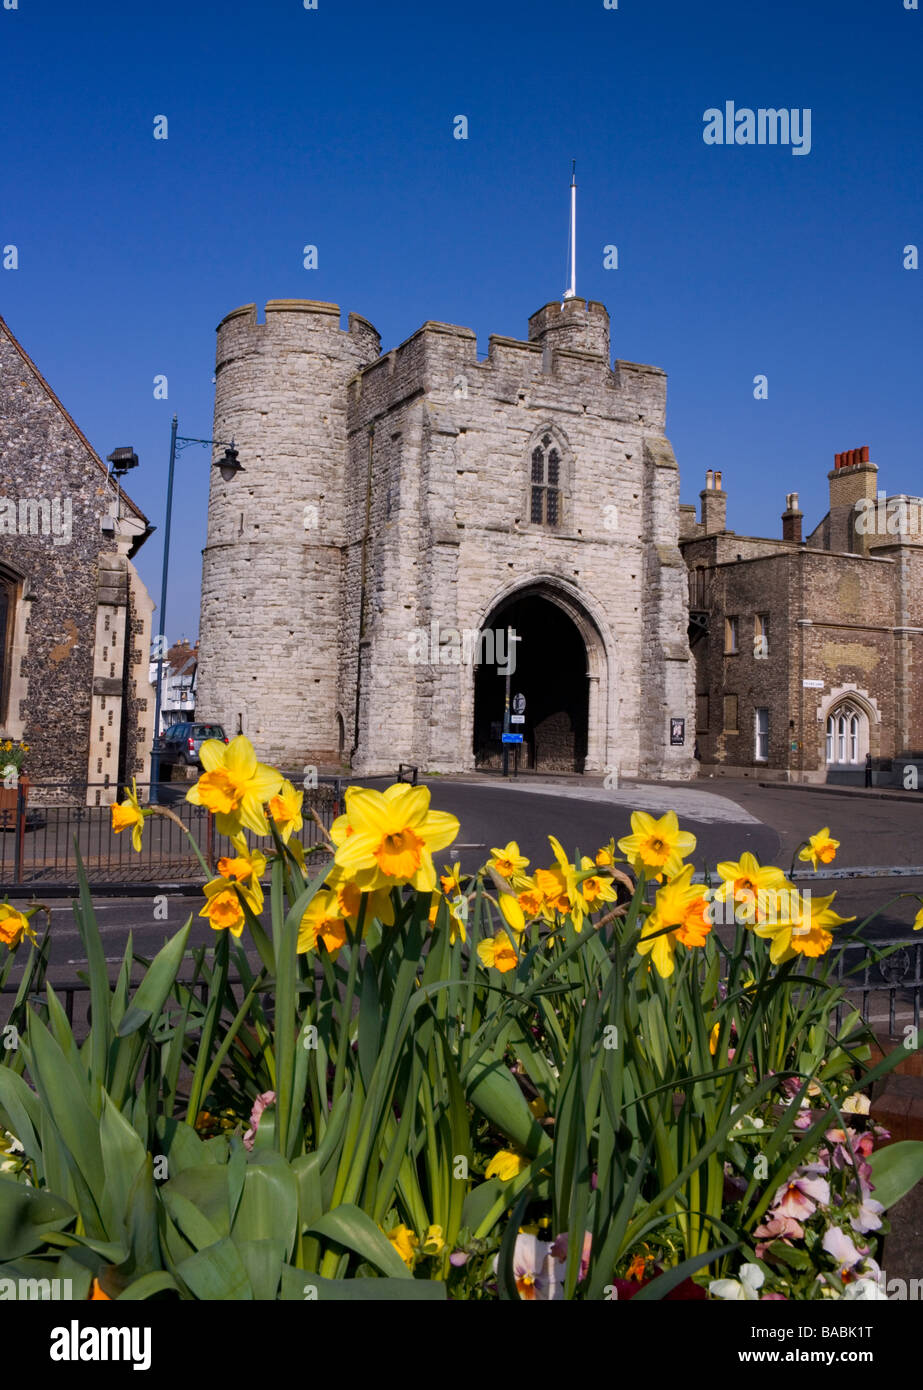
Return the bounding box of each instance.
[0,318,153,805]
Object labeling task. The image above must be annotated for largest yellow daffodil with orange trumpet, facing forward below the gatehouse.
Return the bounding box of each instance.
[332,783,459,892]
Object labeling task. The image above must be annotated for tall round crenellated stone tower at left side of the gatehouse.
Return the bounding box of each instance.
[196,299,381,771]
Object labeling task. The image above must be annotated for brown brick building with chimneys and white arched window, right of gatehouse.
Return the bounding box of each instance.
[680,448,923,784]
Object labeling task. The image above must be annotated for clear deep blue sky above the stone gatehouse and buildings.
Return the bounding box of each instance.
[0,0,923,639]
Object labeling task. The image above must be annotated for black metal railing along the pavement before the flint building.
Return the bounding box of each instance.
[0,777,342,892]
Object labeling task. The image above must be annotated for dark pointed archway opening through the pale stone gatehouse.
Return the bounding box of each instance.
[474,591,591,773]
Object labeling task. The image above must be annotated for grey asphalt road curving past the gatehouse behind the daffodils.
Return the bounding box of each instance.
[1,777,923,981]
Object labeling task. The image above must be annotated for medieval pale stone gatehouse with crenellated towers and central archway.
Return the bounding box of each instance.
[197,297,694,778]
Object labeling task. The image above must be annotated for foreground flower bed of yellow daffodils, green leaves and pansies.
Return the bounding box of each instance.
[0,737,923,1301]
